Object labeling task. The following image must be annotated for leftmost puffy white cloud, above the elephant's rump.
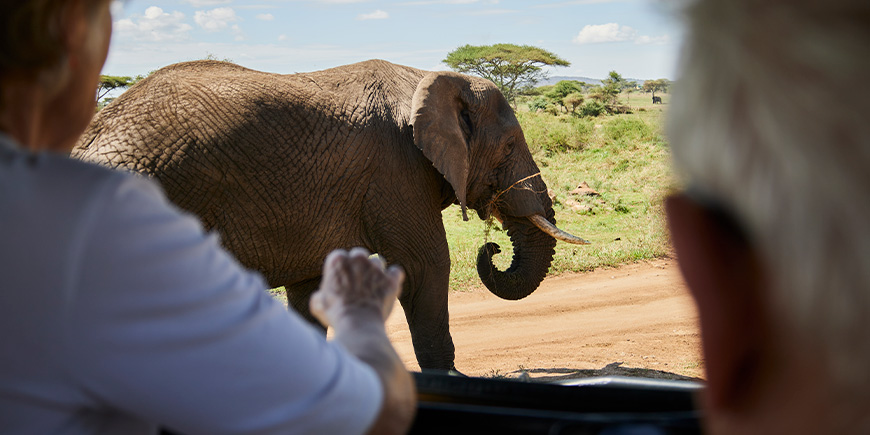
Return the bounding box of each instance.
[114,6,193,41]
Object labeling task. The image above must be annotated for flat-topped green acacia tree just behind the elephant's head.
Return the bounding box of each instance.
[442,44,571,103]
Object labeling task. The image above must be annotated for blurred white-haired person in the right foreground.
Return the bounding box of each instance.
[666,0,870,434]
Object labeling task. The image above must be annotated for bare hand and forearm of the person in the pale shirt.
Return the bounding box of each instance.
[311,248,416,434]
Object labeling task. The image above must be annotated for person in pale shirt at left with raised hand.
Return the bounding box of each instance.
[0,0,416,434]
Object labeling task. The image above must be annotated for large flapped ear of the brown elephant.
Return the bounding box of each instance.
[411,72,473,221]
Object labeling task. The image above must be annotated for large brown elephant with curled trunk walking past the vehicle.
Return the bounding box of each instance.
[72,60,586,370]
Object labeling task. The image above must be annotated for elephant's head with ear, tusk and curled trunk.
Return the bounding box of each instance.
[411,72,588,300]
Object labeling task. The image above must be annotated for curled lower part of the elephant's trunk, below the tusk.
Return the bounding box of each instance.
[477,213,556,300]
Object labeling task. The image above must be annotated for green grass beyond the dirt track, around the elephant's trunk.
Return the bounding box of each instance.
[443,94,674,290]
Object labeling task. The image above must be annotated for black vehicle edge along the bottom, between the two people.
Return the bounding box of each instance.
[410,373,701,435]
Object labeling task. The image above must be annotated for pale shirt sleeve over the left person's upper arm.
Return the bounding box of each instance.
[70,178,383,435]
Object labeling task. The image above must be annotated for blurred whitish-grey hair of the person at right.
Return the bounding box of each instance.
[669,0,870,406]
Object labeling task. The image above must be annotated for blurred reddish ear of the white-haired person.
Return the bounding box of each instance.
[665,195,770,410]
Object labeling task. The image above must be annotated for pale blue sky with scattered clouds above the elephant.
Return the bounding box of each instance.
[103,0,682,79]
